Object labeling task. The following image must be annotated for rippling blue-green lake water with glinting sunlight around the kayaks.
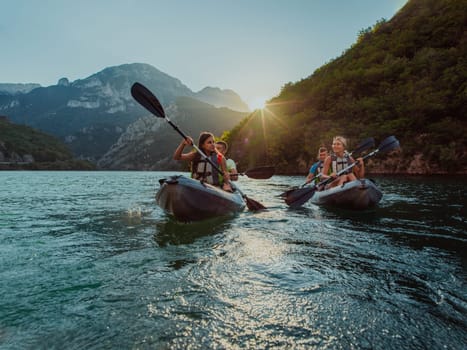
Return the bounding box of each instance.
[0,171,467,349]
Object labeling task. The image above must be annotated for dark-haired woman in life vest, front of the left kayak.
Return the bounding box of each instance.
[173,131,232,192]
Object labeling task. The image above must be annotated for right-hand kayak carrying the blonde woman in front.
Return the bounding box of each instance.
[310,179,383,210]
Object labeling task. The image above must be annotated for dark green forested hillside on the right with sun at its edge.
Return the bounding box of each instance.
[228,0,467,174]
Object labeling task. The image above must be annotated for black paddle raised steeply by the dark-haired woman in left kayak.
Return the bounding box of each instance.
[131,83,266,211]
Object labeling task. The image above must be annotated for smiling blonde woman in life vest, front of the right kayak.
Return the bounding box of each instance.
[321,136,365,188]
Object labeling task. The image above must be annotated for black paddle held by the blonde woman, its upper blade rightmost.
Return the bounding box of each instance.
[284,136,399,208]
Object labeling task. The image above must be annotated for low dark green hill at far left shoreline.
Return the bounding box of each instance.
[0,116,93,170]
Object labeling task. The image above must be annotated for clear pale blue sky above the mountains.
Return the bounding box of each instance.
[0,0,407,108]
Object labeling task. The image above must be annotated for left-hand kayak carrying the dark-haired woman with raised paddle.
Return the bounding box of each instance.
[156,175,245,222]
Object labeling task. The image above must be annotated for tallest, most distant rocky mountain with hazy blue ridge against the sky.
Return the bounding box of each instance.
[0,63,250,162]
